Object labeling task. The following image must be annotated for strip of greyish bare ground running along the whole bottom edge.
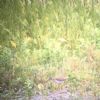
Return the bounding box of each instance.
[0,88,100,100]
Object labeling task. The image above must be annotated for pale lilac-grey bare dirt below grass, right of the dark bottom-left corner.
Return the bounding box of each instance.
[30,89,100,100]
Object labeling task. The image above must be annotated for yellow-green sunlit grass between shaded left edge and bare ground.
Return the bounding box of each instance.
[0,0,100,98]
